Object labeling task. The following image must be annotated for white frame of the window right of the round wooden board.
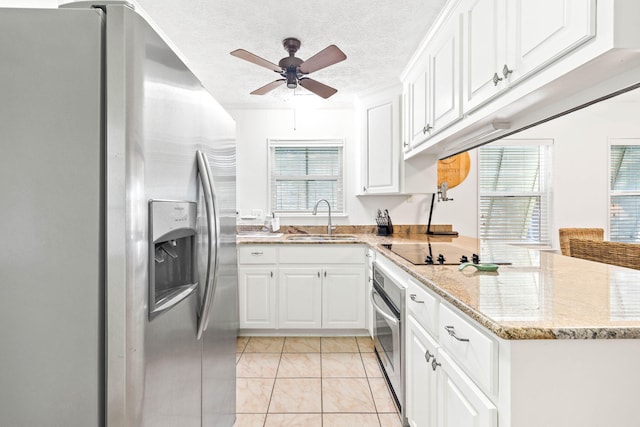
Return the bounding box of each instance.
[477,138,554,249]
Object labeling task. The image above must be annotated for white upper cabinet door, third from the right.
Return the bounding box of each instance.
[427,13,461,133]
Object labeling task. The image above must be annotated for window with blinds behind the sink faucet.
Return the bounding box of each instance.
[269,140,344,214]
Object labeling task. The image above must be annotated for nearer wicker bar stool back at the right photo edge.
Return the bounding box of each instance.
[569,239,640,270]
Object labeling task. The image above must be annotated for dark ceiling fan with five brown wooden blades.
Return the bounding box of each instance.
[231,37,347,99]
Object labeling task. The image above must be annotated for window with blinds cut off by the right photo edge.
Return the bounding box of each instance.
[609,139,640,242]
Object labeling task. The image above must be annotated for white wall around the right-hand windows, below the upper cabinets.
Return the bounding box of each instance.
[436,93,640,248]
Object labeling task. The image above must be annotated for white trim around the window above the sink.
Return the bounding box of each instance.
[267,138,349,218]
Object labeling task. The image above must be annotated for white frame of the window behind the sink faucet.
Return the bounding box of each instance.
[267,138,348,218]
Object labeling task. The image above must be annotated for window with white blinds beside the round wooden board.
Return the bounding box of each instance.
[479,140,552,245]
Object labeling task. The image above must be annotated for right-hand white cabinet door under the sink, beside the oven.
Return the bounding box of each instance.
[322,267,365,329]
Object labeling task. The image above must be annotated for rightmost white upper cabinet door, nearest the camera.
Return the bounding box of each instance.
[506,0,596,82]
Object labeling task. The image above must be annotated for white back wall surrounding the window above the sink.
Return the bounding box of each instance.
[229,106,440,225]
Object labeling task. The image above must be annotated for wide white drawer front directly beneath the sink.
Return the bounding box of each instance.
[280,244,365,264]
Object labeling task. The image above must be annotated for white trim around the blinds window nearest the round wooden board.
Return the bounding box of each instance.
[476,138,555,249]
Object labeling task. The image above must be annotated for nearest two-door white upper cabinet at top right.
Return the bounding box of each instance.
[462,0,595,112]
